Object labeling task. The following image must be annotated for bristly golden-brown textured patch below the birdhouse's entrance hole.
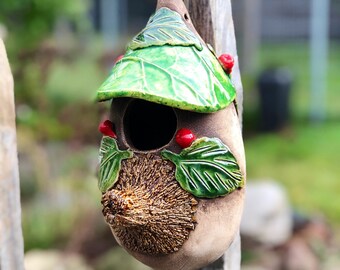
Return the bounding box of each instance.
[102,154,198,255]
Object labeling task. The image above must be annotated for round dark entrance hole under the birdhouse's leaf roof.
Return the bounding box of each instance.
[124,99,177,151]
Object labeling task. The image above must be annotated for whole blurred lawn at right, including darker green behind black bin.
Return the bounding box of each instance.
[243,40,340,226]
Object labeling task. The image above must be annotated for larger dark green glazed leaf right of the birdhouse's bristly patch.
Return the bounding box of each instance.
[162,138,243,198]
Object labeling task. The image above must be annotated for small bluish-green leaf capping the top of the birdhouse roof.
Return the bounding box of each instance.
[128,8,202,50]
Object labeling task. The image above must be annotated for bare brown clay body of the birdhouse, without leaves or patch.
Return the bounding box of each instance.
[110,98,245,270]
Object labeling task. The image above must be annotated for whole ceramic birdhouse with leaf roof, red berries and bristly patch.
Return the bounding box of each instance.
[97,2,245,270]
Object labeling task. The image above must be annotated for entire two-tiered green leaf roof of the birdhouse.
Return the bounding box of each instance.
[97,8,236,112]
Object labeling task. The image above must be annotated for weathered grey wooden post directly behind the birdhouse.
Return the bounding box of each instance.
[184,0,243,270]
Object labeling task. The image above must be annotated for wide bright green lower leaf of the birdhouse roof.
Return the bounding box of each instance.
[97,45,236,113]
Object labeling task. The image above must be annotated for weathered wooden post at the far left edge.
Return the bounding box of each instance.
[0,39,24,270]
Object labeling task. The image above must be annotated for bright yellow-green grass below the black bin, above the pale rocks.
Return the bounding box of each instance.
[245,122,340,225]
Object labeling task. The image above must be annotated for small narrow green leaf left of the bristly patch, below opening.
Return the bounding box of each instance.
[98,136,133,193]
